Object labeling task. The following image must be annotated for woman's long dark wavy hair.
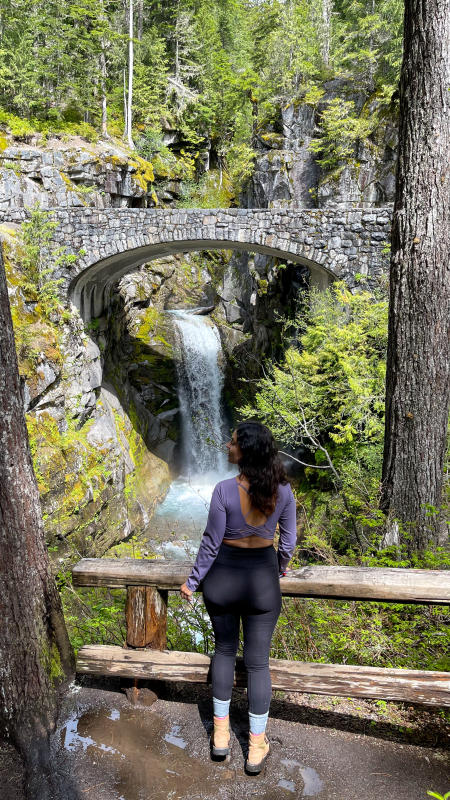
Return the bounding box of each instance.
[236,421,287,516]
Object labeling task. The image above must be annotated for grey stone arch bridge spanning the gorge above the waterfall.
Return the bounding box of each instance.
[1,208,391,321]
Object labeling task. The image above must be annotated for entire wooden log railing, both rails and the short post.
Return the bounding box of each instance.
[72,559,450,706]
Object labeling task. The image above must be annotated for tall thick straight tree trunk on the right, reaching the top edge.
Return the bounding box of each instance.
[381,0,450,549]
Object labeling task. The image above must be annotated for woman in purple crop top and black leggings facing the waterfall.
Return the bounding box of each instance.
[181,422,296,774]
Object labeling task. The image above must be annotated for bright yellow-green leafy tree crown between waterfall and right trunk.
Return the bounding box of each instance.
[241,283,387,461]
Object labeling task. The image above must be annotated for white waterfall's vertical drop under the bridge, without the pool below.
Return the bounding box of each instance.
[170,311,227,475]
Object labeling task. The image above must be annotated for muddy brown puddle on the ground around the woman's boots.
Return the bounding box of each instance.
[58,698,324,800]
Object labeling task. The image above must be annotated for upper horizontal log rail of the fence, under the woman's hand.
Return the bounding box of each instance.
[72,558,450,605]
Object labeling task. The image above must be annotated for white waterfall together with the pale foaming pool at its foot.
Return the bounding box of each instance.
[150,311,235,558]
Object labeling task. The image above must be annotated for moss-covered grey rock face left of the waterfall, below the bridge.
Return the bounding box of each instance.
[0,226,169,556]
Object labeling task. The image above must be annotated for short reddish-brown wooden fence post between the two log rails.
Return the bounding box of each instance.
[125,586,168,650]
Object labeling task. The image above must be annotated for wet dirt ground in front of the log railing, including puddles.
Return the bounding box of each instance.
[0,678,450,800]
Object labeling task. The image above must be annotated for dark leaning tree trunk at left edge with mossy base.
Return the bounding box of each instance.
[0,250,75,800]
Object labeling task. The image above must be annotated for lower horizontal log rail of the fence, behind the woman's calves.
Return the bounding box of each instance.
[77,645,450,706]
